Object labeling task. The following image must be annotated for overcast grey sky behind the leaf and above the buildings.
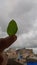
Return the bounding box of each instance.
[0,0,37,52]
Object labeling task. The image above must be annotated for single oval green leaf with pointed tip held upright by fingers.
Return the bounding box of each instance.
[7,20,18,35]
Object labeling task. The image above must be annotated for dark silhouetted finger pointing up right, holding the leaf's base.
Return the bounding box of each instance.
[0,35,17,51]
